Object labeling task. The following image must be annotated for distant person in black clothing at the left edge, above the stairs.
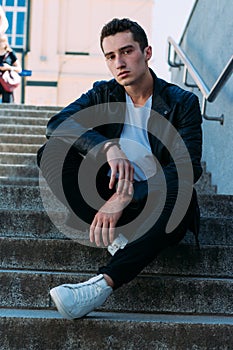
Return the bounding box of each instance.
[0,34,22,103]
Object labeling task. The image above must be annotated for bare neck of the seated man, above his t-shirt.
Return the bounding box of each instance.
[125,70,154,106]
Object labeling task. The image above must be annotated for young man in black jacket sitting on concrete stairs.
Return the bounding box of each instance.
[38,19,202,319]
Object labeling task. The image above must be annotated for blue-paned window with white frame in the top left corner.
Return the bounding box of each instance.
[0,0,29,49]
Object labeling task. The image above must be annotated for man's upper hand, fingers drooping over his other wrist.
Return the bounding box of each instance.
[106,144,134,195]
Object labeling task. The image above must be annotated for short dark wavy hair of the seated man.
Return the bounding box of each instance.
[100,18,148,52]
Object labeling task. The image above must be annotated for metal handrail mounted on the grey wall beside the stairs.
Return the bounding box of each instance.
[168,37,233,124]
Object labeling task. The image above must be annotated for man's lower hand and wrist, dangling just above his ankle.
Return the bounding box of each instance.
[90,193,132,247]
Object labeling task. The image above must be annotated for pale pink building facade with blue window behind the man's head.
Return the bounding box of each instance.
[0,0,154,106]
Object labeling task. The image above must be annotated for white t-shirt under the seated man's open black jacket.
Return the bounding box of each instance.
[119,94,156,181]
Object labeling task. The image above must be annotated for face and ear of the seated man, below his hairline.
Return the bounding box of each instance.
[102,31,151,86]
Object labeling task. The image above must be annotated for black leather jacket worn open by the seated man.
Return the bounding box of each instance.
[46,71,202,183]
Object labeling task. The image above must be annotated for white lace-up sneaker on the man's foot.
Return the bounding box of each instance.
[50,275,113,320]
